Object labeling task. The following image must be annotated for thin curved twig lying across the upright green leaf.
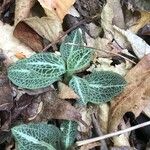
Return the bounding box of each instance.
[66,43,136,64]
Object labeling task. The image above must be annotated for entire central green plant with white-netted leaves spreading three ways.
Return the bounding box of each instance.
[8,29,126,104]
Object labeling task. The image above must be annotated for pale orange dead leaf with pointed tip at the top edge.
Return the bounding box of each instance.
[38,0,75,20]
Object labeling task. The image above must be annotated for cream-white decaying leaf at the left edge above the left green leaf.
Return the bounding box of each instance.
[0,22,35,64]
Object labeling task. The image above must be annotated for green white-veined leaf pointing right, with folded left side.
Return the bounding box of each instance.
[69,71,126,105]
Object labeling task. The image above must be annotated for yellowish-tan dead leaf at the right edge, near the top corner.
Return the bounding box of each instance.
[130,11,150,33]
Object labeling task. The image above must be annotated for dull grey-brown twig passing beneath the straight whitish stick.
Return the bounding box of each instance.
[92,114,108,150]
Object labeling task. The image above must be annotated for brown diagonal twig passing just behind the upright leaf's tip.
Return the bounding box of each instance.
[42,19,86,52]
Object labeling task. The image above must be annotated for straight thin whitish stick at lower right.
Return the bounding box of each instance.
[76,121,150,146]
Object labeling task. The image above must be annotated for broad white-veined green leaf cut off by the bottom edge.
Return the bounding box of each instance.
[12,123,61,150]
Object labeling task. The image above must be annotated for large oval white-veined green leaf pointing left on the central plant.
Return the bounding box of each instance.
[8,53,66,89]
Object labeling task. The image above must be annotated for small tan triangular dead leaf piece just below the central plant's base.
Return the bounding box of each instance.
[58,82,79,99]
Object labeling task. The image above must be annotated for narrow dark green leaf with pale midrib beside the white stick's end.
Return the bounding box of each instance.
[60,120,78,149]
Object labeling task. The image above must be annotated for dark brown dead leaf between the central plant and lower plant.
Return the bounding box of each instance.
[35,91,81,122]
